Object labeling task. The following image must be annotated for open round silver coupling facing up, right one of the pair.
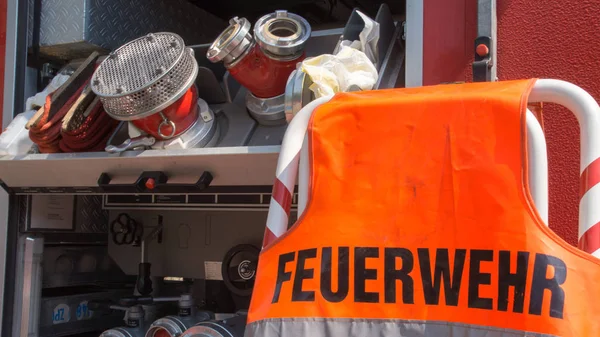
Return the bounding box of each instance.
[254,10,311,56]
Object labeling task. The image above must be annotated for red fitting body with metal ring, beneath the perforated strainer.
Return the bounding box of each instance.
[131,85,198,140]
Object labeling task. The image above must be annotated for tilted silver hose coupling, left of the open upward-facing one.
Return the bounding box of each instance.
[206,16,253,63]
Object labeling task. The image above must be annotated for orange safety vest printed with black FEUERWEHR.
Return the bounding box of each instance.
[246,80,600,337]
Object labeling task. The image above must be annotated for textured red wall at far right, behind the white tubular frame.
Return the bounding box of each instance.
[498,0,600,245]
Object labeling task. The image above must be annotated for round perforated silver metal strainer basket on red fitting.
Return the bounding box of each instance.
[91,32,198,120]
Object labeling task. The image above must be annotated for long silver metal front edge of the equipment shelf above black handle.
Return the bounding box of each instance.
[0,146,280,187]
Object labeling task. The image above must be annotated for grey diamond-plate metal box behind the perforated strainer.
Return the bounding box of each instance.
[35,0,226,58]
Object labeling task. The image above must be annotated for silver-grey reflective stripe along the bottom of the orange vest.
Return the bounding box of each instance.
[244,318,558,337]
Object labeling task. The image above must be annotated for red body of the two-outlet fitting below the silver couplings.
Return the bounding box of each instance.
[228,45,306,98]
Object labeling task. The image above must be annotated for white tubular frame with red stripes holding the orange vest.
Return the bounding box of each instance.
[263,79,600,257]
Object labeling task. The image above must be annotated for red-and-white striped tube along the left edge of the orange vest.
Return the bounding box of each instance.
[263,96,331,248]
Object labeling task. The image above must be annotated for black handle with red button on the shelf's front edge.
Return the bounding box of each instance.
[98,171,213,193]
